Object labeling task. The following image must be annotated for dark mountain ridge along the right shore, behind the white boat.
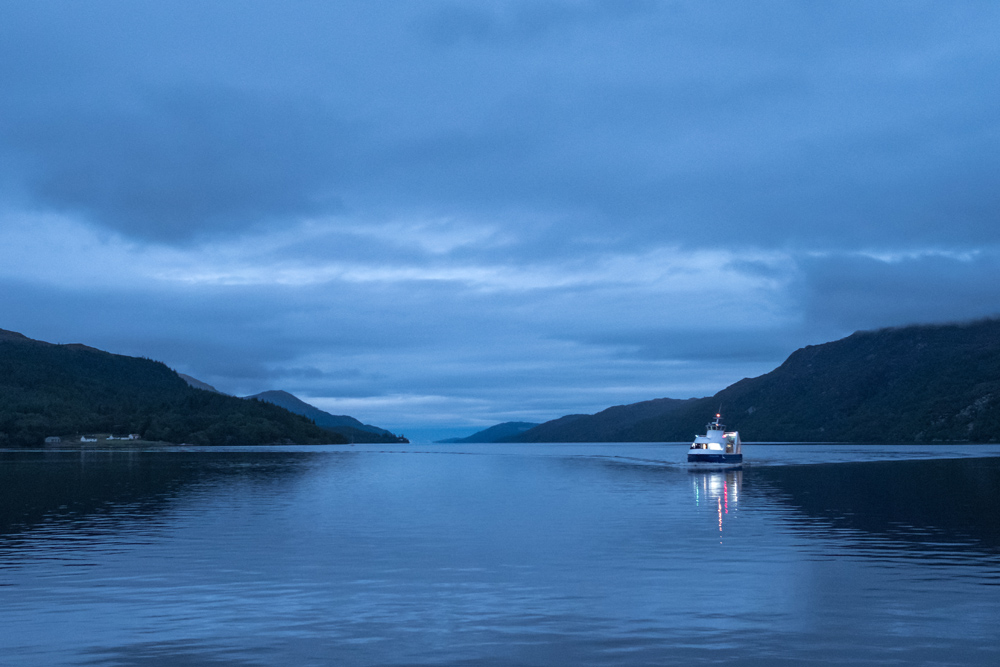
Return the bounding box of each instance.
[503,319,1000,442]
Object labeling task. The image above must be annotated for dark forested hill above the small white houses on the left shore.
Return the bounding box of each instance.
[0,330,344,446]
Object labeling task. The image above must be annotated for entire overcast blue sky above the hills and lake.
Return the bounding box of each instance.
[0,0,1000,439]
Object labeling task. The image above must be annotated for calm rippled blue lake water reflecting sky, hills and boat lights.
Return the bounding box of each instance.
[0,444,1000,666]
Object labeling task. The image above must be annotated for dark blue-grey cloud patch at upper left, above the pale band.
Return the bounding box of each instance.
[0,89,356,240]
